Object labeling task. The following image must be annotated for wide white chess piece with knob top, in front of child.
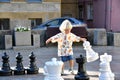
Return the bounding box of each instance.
[44,58,64,80]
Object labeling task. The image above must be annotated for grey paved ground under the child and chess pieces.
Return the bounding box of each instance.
[0,46,120,80]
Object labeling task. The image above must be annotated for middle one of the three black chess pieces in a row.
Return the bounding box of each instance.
[14,53,25,75]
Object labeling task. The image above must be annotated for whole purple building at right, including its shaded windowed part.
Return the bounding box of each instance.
[78,0,120,32]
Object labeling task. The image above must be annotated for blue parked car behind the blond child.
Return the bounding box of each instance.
[33,17,87,30]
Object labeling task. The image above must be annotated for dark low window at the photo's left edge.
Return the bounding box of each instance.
[0,19,10,30]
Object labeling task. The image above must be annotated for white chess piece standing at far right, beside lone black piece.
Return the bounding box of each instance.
[99,53,115,80]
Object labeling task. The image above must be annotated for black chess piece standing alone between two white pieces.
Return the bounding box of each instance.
[75,55,89,80]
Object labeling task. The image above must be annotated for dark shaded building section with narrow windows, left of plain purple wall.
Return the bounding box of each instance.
[78,0,94,28]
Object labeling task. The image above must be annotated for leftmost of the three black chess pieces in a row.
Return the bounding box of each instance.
[0,52,12,76]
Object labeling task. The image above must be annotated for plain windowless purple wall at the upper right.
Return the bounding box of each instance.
[94,0,120,32]
